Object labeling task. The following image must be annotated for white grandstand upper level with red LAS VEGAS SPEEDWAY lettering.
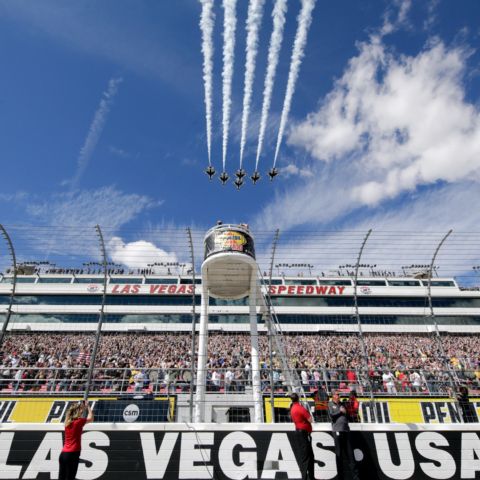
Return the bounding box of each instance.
[0,271,480,333]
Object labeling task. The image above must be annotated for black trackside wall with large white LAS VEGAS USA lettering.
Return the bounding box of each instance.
[0,426,480,480]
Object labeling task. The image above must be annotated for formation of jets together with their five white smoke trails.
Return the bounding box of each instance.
[199,0,317,190]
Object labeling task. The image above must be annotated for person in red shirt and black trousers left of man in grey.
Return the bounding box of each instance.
[290,393,315,480]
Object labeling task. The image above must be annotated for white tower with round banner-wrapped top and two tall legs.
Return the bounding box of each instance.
[195,224,263,423]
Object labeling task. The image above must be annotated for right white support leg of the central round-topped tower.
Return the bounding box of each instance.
[249,268,263,423]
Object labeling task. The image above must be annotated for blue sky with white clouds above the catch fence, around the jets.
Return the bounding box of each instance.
[0,0,480,251]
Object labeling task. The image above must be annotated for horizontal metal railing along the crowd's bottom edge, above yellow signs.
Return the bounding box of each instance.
[0,366,480,397]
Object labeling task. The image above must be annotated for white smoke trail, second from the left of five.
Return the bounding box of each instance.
[222,0,237,170]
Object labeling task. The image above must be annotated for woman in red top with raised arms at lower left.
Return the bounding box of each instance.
[58,401,93,480]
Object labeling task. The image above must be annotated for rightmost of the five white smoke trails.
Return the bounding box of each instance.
[273,0,316,167]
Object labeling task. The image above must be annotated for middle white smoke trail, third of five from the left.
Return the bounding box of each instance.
[240,0,265,168]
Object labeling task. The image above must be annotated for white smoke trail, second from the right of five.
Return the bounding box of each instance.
[255,0,287,171]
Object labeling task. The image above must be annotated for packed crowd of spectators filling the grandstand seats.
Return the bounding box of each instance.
[0,332,480,394]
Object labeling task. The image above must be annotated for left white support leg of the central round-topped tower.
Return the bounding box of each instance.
[195,284,209,423]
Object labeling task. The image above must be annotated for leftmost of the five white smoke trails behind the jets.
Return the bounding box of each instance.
[200,0,215,165]
